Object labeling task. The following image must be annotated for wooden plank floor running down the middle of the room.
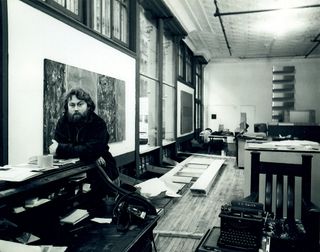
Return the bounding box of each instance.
[153,157,244,252]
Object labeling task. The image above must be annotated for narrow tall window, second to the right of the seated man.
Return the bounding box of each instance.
[162,33,176,145]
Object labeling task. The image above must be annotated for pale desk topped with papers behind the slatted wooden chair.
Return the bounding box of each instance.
[244,142,320,212]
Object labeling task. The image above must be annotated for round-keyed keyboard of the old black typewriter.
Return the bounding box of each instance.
[218,230,260,251]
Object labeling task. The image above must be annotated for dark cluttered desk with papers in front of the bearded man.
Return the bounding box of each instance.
[0,162,158,252]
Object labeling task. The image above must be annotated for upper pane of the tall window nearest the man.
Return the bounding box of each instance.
[140,7,158,79]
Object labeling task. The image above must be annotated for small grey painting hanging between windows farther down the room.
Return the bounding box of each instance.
[181,90,193,134]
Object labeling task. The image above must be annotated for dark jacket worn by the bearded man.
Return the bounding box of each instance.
[54,112,119,180]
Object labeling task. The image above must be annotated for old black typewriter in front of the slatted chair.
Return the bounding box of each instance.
[217,200,264,251]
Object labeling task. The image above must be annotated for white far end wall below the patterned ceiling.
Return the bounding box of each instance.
[204,58,320,132]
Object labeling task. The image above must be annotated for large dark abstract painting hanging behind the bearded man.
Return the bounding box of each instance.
[43,59,126,153]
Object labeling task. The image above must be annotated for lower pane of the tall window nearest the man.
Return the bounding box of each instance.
[139,76,159,146]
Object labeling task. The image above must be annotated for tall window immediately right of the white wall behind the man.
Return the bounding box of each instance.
[139,7,159,146]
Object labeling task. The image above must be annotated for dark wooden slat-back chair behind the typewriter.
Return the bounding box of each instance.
[246,152,320,251]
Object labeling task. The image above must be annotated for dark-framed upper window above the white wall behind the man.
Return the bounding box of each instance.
[42,0,130,47]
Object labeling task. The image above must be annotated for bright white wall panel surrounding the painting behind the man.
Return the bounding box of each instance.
[8,0,136,164]
